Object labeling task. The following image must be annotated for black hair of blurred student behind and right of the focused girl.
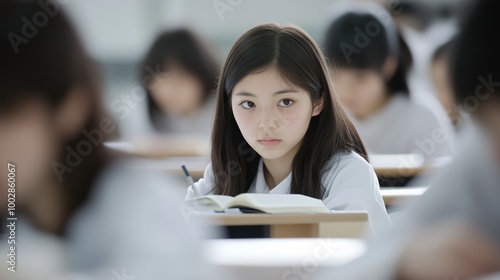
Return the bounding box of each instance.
[324,4,412,95]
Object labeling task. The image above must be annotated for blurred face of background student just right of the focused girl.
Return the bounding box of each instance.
[332,68,387,120]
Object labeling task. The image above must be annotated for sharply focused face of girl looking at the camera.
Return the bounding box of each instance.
[231,68,322,160]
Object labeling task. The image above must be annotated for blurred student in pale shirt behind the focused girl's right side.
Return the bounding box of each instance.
[324,4,453,158]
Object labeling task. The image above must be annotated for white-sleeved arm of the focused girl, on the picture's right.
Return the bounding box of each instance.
[323,154,391,236]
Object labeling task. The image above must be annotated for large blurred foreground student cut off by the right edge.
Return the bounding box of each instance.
[316,0,500,280]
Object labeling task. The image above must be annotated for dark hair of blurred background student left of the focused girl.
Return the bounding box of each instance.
[140,28,219,131]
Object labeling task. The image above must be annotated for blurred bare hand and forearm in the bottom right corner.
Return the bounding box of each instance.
[397,223,500,280]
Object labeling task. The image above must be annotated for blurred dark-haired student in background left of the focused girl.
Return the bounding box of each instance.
[141,29,219,138]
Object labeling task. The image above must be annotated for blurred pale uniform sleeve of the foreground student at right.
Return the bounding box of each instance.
[313,125,500,280]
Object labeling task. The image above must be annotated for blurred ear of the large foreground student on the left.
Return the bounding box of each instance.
[54,88,90,139]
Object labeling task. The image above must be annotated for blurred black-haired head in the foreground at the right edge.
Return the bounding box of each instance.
[450,0,500,159]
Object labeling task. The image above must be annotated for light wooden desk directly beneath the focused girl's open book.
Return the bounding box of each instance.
[199,211,368,238]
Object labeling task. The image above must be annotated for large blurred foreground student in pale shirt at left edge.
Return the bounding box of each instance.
[0,1,223,279]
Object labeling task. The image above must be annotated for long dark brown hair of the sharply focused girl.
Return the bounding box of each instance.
[212,24,368,198]
